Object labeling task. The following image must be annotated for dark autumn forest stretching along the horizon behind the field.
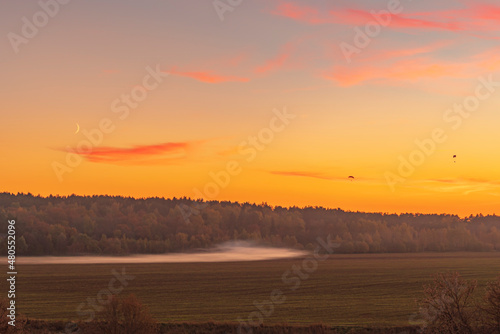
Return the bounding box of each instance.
[0,193,500,256]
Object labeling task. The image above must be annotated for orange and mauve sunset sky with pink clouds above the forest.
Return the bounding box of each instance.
[0,0,500,216]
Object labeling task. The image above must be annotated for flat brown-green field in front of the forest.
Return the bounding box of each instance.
[6,253,500,326]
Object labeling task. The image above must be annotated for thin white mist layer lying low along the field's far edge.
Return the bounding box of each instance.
[18,241,308,264]
